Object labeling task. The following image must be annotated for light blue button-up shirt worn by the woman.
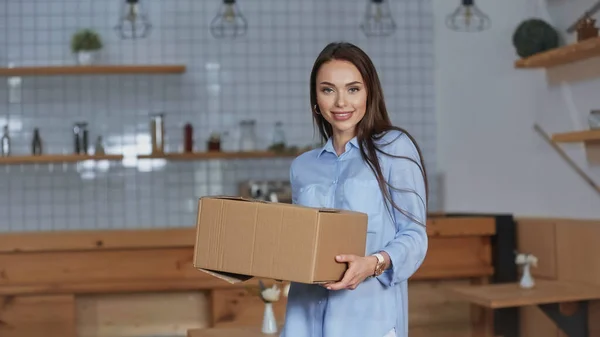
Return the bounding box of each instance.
[281,131,428,337]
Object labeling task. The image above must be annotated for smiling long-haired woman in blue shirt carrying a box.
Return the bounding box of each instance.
[282,43,428,337]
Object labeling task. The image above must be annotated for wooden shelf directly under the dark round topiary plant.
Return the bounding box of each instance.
[515,37,600,68]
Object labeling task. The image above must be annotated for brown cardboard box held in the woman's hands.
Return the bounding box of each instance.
[193,196,367,283]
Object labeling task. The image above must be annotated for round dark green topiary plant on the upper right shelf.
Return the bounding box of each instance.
[512,19,560,57]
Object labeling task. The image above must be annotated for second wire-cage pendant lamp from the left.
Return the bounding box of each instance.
[210,0,248,39]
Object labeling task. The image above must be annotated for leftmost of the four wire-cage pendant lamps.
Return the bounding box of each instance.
[115,0,152,39]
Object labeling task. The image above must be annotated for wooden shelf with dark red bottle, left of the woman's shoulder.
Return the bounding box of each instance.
[138,151,298,160]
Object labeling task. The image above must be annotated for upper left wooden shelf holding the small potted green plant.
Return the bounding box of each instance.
[0,65,186,76]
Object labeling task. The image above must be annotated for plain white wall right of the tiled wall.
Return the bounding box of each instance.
[434,0,600,218]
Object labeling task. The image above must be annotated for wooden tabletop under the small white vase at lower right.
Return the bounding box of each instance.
[450,280,600,309]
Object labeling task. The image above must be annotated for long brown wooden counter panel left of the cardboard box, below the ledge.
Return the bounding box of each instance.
[0,248,209,289]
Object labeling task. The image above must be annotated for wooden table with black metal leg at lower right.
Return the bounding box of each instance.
[449,280,600,337]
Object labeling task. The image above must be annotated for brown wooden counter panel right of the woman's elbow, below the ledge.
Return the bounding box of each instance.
[411,236,494,279]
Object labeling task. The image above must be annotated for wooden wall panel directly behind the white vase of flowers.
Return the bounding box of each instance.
[517,219,558,280]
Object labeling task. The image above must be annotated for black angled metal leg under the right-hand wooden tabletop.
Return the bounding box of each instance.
[538,301,589,337]
